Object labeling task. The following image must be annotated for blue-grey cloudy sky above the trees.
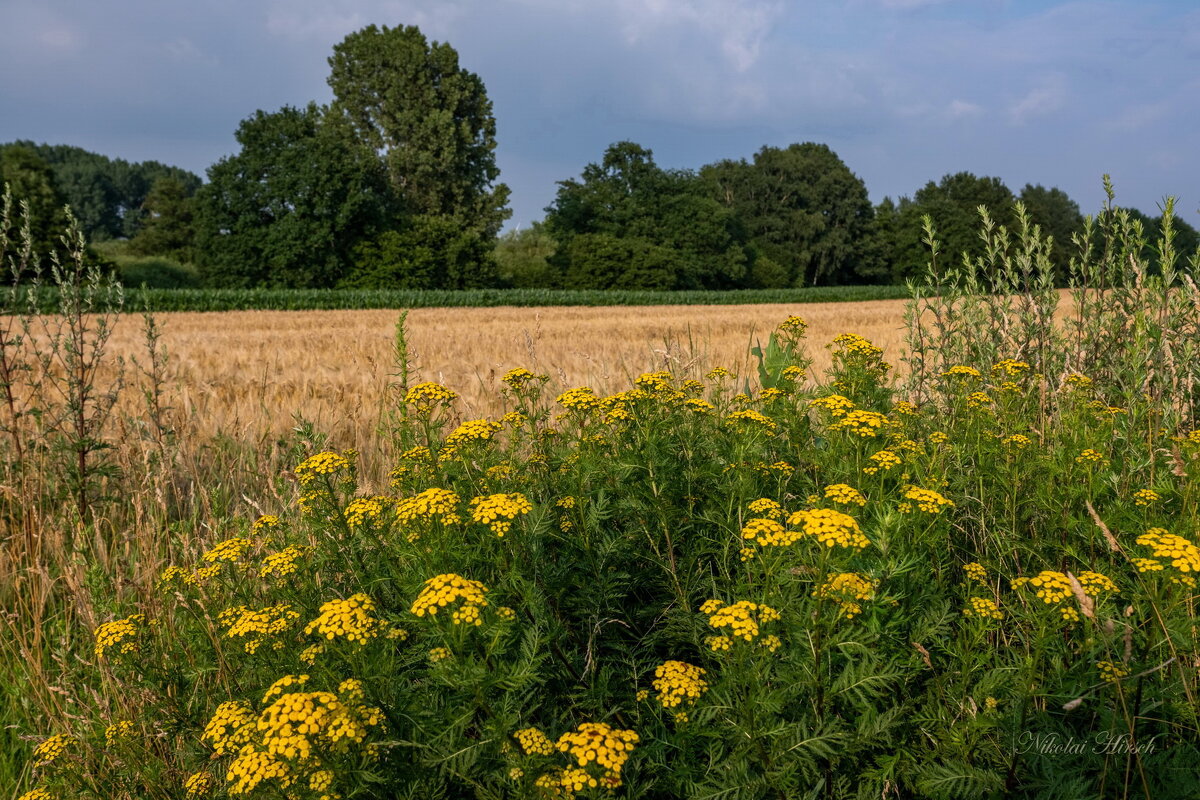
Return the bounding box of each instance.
[0,0,1200,228]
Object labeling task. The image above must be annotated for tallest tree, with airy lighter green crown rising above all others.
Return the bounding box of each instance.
[329,25,511,241]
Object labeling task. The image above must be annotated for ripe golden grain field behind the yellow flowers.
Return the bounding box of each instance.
[105,300,904,451]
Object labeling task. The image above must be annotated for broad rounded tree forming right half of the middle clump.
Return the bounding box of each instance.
[700,142,881,287]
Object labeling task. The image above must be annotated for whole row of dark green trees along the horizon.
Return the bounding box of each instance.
[0,25,1200,290]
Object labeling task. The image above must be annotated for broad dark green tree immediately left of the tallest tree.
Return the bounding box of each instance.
[196,103,395,288]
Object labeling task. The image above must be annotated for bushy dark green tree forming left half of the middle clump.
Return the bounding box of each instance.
[546,142,748,289]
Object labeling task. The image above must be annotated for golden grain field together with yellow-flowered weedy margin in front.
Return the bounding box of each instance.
[0,201,1200,800]
